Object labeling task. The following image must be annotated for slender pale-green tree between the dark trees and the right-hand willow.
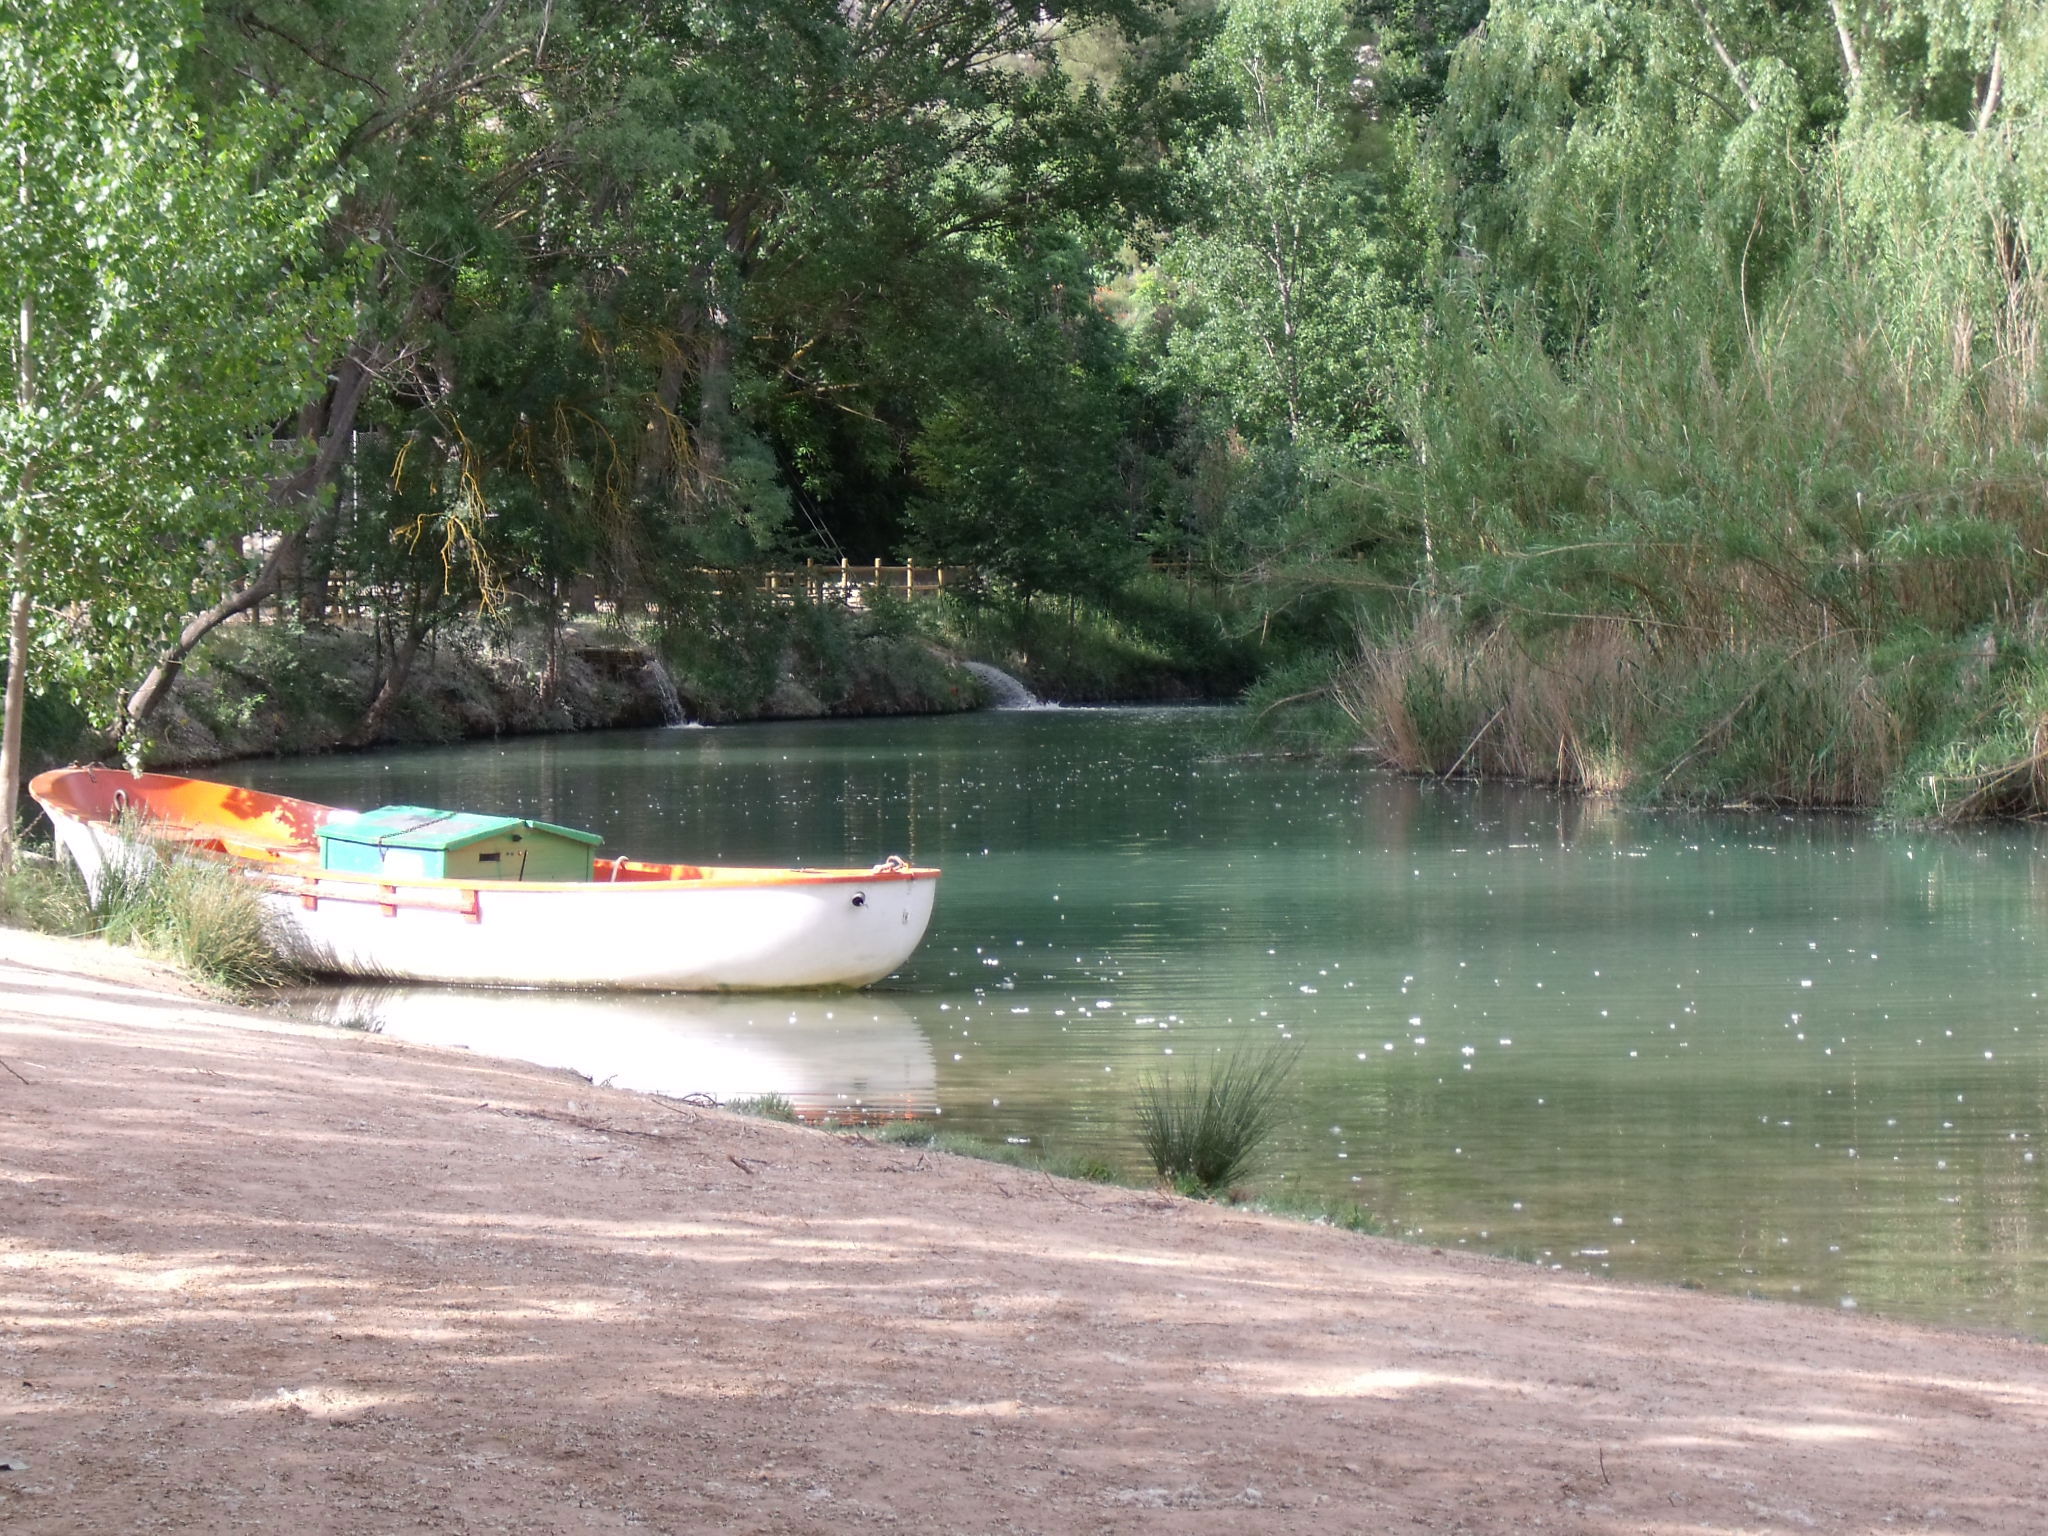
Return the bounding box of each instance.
[1153,0,1413,598]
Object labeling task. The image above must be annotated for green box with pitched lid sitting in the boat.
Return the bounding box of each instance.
[319,805,604,881]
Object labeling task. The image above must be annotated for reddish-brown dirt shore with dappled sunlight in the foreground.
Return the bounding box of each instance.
[0,932,2048,1536]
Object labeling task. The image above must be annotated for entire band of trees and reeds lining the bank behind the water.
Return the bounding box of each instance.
[0,0,2048,843]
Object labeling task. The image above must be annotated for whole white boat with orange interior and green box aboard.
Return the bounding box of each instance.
[29,768,938,991]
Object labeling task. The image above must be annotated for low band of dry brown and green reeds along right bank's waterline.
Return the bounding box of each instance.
[1329,612,1982,813]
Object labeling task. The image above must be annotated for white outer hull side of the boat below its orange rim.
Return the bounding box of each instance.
[51,811,938,991]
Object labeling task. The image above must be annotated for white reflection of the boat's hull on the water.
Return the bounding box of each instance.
[283,985,938,1118]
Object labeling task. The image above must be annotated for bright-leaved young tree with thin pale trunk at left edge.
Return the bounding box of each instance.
[0,0,340,862]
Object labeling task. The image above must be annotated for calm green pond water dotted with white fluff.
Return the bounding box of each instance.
[240,711,2048,1333]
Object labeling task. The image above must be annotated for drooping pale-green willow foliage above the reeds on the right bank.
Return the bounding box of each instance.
[1411,0,2048,614]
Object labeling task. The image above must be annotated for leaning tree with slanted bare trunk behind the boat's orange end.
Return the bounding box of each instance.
[111,0,575,737]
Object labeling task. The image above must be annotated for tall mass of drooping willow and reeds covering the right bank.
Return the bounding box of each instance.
[1269,0,2048,815]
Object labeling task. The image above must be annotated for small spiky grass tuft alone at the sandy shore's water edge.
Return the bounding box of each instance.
[1135,1040,1300,1196]
